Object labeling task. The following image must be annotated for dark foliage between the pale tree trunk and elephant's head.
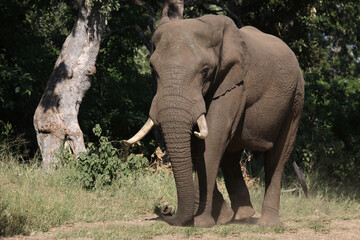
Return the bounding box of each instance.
[79,2,153,146]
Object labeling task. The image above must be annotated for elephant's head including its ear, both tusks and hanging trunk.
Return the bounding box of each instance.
[127,15,247,225]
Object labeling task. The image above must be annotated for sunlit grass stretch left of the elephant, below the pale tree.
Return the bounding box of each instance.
[0,158,176,235]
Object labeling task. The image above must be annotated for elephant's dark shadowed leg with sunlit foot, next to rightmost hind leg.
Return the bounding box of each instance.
[220,151,255,221]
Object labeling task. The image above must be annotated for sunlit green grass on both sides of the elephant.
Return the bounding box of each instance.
[0,140,360,239]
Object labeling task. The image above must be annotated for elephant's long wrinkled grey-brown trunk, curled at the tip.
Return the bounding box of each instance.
[150,85,207,226]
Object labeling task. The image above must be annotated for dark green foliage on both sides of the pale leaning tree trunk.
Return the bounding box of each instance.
[0,0,158,148]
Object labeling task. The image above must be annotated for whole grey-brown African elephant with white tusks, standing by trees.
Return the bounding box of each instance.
[127,15,304,227]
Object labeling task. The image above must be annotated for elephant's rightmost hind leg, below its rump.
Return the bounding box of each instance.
[258,109,300,226]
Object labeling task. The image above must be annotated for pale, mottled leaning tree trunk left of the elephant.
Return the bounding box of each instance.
[34,0,105,171]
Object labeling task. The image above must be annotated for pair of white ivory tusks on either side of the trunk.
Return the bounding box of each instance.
[124,114,209,146]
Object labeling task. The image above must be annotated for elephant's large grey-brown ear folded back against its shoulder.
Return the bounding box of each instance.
[199,15,250,99]
